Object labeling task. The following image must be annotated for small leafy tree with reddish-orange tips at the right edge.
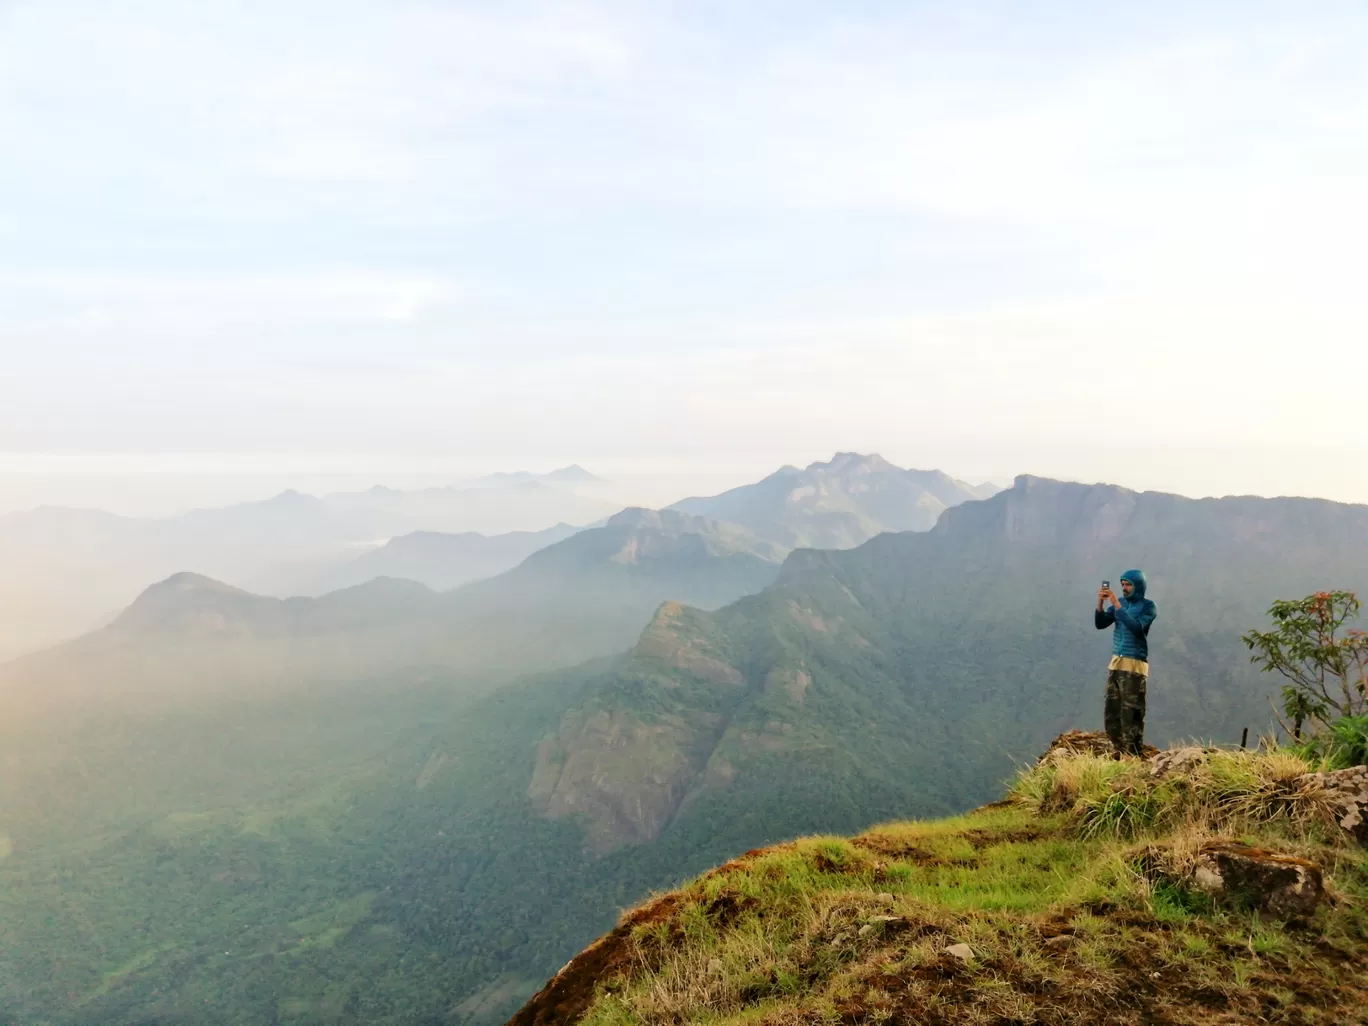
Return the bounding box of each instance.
[1241,591,1368,740]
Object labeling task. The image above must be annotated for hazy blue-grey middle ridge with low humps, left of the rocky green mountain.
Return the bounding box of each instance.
[0,510,782,714]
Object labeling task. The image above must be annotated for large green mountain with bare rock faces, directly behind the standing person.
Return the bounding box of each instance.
[517,477,1368,850]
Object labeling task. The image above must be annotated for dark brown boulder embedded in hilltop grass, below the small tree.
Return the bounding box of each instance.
[1192,841,1324,919]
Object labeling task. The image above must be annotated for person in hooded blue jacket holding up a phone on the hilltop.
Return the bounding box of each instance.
[1093,570,1159,757]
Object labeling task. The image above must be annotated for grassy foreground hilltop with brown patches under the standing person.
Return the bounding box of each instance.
[510,750,1368,1026]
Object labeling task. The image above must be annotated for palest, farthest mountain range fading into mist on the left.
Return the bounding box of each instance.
[0,468,618,659]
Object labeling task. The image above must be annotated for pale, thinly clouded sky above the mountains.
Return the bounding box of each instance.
[0,0,1368,512]
